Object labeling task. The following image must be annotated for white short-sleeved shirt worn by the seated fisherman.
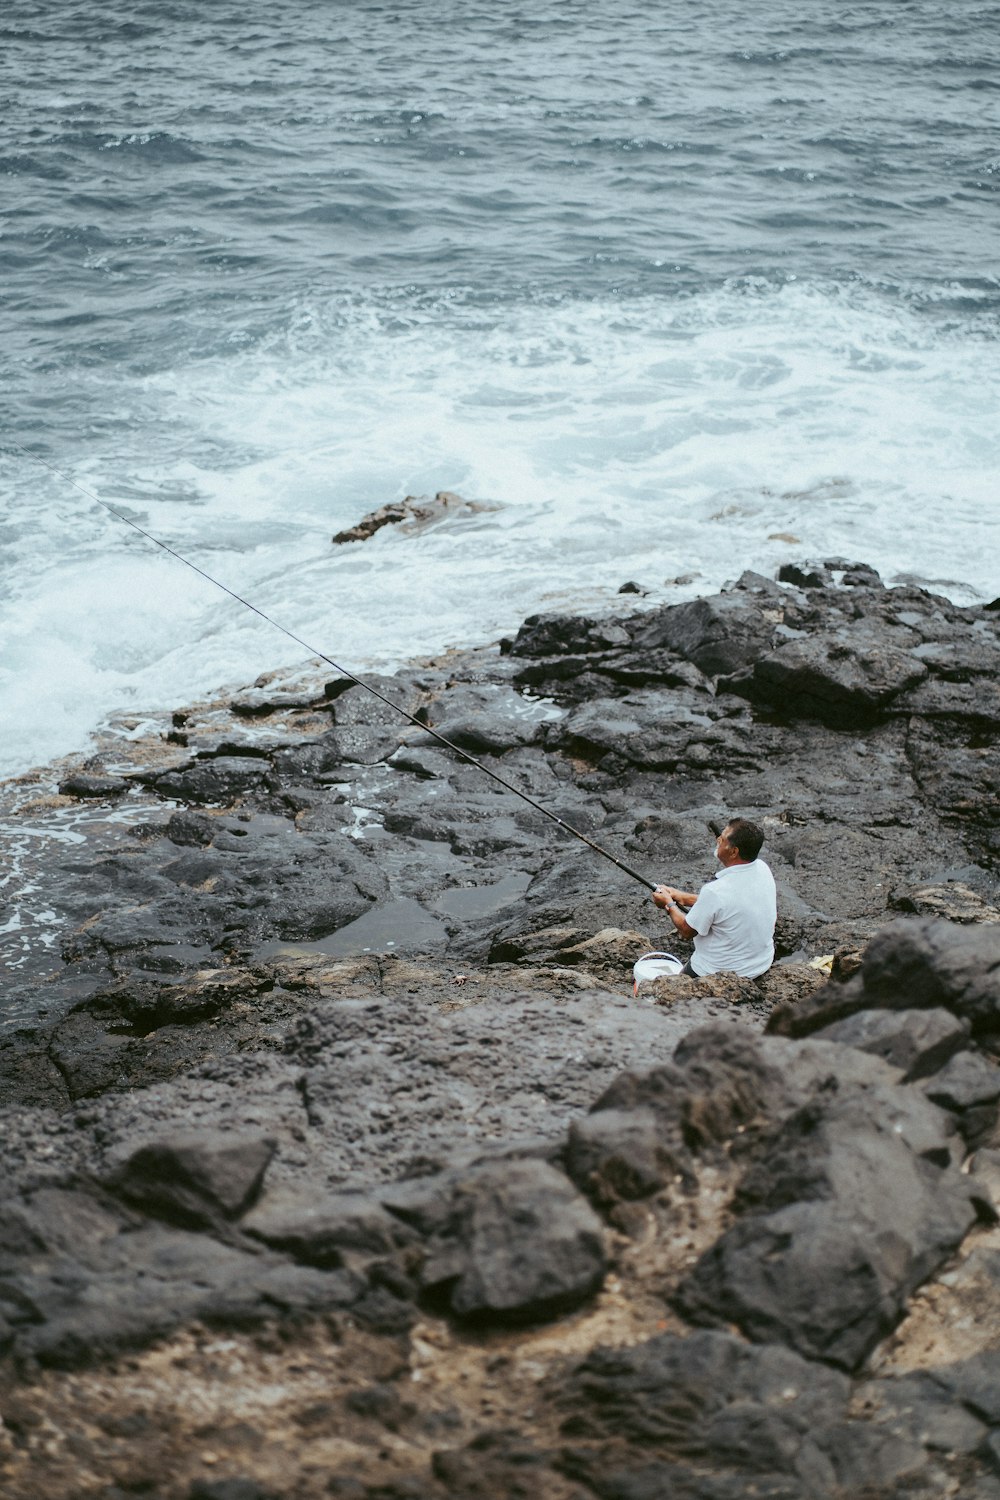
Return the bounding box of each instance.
[687,860,778,980]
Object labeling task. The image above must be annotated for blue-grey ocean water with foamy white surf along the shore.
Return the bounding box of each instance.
[0,0,1000,774]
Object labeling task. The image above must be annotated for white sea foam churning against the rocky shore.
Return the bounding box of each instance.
[0,282,1000,774]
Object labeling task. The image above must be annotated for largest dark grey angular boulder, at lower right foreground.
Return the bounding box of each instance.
[676,1095,976,1370]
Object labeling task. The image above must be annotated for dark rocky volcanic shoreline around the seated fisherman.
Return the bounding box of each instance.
[0,560,1000,1500]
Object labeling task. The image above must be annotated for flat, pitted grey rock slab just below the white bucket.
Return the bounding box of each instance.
[281,990,710,1187]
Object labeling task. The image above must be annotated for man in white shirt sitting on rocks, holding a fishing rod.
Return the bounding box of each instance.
[652,818,777,980]
